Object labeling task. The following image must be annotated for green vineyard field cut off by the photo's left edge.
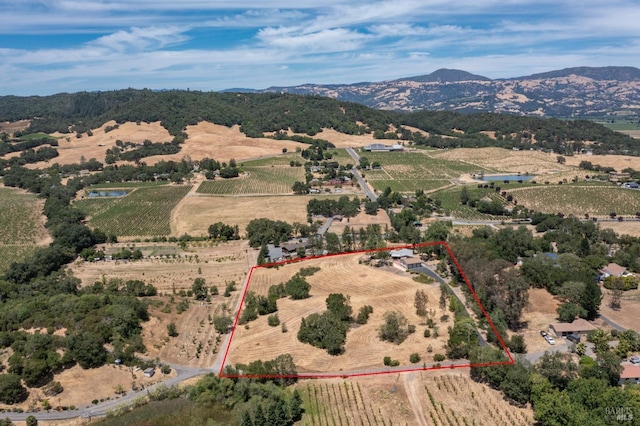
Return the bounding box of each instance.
[0,187,50,272]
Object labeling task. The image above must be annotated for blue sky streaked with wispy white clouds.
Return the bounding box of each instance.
[0,0,640,95]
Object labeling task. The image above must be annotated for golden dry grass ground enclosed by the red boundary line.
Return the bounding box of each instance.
[227,255,453,373]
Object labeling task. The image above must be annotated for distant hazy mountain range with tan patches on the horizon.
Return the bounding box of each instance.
[250,66,640,118]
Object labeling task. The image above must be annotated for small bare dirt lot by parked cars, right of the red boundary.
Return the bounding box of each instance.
[518,288,560,352]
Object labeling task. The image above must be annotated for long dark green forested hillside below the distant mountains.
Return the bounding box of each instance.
[0,89,640,155]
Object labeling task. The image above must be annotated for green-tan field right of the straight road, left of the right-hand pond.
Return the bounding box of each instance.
[360,151,496,192]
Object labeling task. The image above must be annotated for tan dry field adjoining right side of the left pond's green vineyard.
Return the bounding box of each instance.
[171,195,328,236]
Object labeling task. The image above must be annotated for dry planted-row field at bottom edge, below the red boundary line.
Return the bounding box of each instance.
[296,369,534,426]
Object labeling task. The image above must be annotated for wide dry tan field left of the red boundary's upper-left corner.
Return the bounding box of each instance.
[70,240,251,293]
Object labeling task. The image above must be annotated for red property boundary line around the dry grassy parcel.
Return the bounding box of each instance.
[218,241,515,379]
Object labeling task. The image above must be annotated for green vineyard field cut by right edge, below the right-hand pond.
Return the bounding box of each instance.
[508,184,640,217]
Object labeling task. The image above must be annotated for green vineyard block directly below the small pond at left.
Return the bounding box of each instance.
[74,185,191,237]
